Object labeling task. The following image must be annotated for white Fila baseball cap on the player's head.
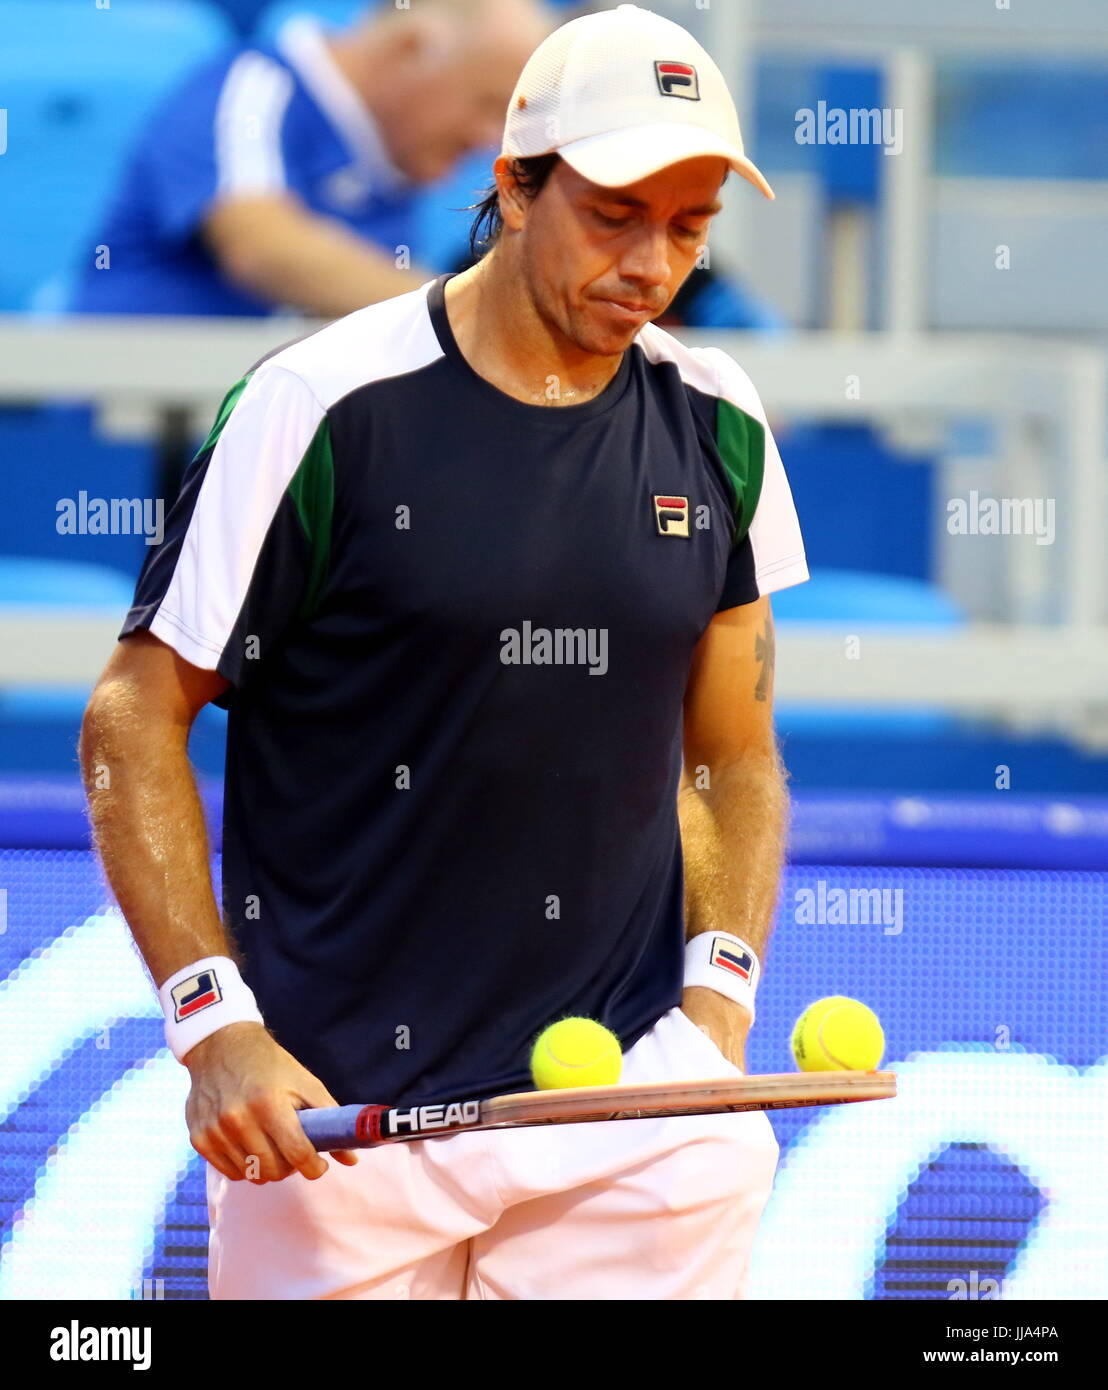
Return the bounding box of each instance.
[502,4,773,197]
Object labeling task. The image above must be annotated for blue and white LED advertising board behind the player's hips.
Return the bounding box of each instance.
[0,798,1108,1300]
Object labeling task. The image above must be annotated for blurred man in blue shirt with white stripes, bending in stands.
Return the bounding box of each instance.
[71,0,553,317]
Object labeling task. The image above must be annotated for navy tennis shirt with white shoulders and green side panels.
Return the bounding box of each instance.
[122,277,808,1104]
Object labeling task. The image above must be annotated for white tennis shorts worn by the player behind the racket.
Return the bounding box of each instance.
[207,1009,777,1300]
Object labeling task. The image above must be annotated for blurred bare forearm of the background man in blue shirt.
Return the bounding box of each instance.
[203,195,432,318]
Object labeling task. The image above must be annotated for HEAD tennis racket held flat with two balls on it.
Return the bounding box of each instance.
[300,1072,897,1152]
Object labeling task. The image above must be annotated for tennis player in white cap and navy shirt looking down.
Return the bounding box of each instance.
[82,6,806,1300]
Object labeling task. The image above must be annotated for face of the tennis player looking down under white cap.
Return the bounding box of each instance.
[520,156,727,356]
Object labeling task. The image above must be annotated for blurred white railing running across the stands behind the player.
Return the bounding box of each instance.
[0,316,1108,746]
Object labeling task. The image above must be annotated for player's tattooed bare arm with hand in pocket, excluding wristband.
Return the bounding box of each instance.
[678,598,788,1066]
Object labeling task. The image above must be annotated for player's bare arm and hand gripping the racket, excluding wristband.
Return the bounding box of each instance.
[81,632,356,1182]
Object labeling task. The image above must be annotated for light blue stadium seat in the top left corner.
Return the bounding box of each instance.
[0,0,234,310]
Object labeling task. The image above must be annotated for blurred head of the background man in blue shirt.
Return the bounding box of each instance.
[332,0,556,182]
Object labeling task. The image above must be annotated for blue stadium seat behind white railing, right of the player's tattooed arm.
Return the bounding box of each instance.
[772,569,965,737]
